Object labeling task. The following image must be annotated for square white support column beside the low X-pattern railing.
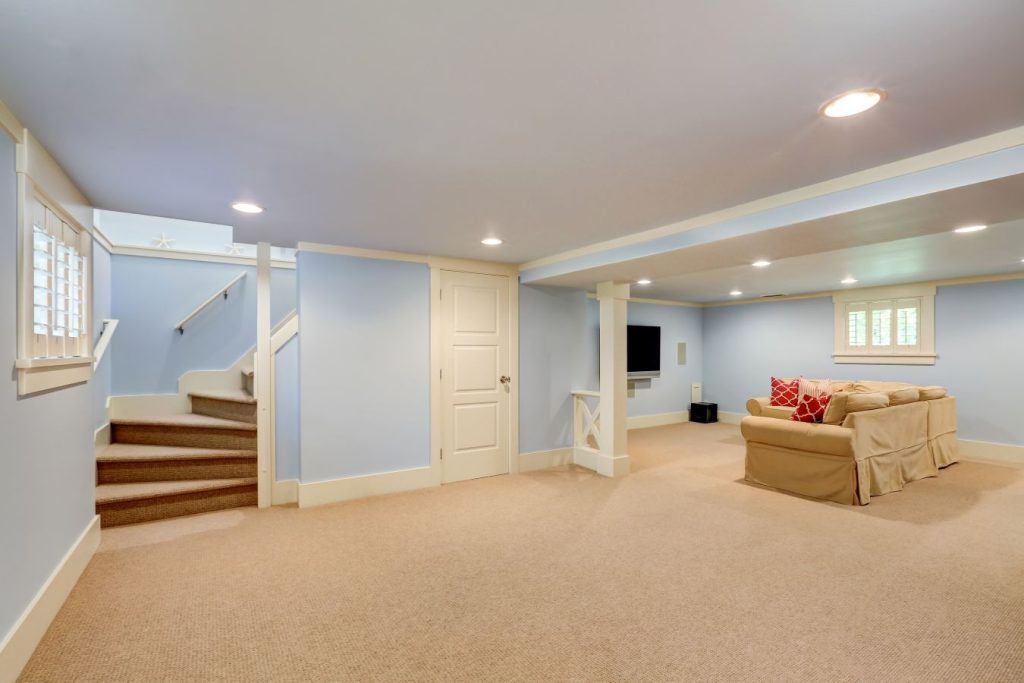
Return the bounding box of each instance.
[597,283,630,477]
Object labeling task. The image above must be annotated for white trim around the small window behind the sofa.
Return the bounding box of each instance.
[833,285,938,366]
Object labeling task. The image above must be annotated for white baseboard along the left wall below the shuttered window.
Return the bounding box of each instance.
[0,515,99,683]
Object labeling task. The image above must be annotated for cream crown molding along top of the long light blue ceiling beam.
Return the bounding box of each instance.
[519,126,1024,272]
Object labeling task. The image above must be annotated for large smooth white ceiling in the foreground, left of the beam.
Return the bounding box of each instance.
[0,0,1024,262]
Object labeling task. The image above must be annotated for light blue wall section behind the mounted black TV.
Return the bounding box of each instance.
[627,303,703,417]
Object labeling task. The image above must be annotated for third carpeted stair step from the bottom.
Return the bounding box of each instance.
[111,414,256,451]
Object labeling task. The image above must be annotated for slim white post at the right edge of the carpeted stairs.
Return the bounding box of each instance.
[254,242,273,508]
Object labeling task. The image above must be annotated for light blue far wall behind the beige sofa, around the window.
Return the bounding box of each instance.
[703,280,1024,445]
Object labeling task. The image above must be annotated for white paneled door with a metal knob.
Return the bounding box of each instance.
[440,270,511,481]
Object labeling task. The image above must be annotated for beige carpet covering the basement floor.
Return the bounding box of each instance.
[16,424,1024,681]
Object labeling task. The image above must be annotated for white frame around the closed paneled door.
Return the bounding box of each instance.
[428,257,519,485]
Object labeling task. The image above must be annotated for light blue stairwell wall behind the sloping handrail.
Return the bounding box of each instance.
[111,255,296,395]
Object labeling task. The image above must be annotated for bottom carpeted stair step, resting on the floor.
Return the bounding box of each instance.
[96,477,257,526]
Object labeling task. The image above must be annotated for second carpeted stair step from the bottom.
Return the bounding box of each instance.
[96,443,256,484]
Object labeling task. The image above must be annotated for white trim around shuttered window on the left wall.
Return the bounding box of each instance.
[14,172,93,395]
